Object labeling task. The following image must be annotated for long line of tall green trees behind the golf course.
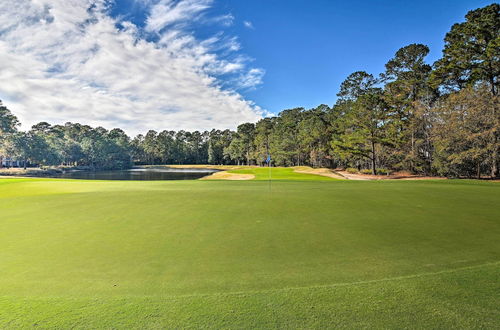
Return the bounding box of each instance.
[0,3,500,177]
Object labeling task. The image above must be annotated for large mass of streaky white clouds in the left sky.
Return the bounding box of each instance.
[0,0,265,134]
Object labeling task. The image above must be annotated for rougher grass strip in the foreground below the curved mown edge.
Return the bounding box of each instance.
[0,263,500,329]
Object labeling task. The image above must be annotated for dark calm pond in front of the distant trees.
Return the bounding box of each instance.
[51,168,217,180]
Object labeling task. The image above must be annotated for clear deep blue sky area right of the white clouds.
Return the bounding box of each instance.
[211,0,492,112]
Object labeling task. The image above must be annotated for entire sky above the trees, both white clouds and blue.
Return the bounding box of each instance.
[0,0,492,135]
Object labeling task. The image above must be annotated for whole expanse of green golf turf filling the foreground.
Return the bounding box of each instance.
[0,178,500,328]
